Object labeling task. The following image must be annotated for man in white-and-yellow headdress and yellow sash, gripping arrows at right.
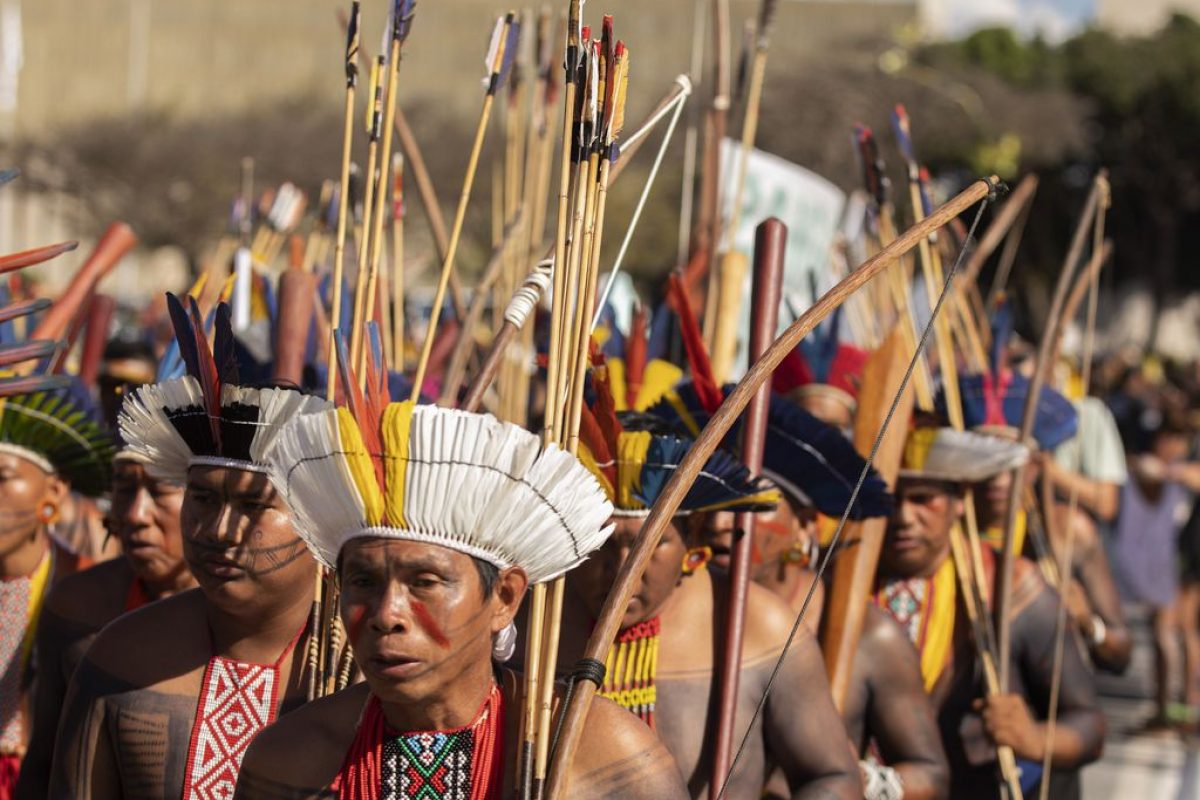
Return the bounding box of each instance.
[877,428,1104,798]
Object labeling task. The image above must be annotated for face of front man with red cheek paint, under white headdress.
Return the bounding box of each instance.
[338,537,527,703]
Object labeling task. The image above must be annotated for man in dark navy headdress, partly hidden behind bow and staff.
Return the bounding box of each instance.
[652,383,948,800]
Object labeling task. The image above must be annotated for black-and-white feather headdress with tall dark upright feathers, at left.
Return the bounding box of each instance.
[120,295,329,482]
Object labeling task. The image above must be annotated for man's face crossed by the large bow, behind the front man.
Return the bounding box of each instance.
[569,517,688,628]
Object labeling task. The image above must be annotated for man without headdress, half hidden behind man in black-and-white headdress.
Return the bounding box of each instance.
[17,450,196,800]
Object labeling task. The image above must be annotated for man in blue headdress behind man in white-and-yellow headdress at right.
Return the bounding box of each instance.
[959,368,1133,673]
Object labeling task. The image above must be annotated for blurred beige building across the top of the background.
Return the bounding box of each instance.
[0,0,917,138]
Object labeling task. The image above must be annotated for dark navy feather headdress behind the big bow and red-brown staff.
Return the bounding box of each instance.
[649,381,892,521]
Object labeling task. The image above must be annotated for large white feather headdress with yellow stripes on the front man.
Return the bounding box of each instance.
[269,402,612,583]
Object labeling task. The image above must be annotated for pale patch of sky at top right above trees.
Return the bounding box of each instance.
[922,0,1097,42]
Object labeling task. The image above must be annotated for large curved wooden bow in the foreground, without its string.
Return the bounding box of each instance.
[546,176,1000,800]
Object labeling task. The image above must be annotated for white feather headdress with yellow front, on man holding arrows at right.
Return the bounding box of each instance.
[900,427,1030,483]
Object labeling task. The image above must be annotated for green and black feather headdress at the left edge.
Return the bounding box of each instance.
[0,384,115,497]
